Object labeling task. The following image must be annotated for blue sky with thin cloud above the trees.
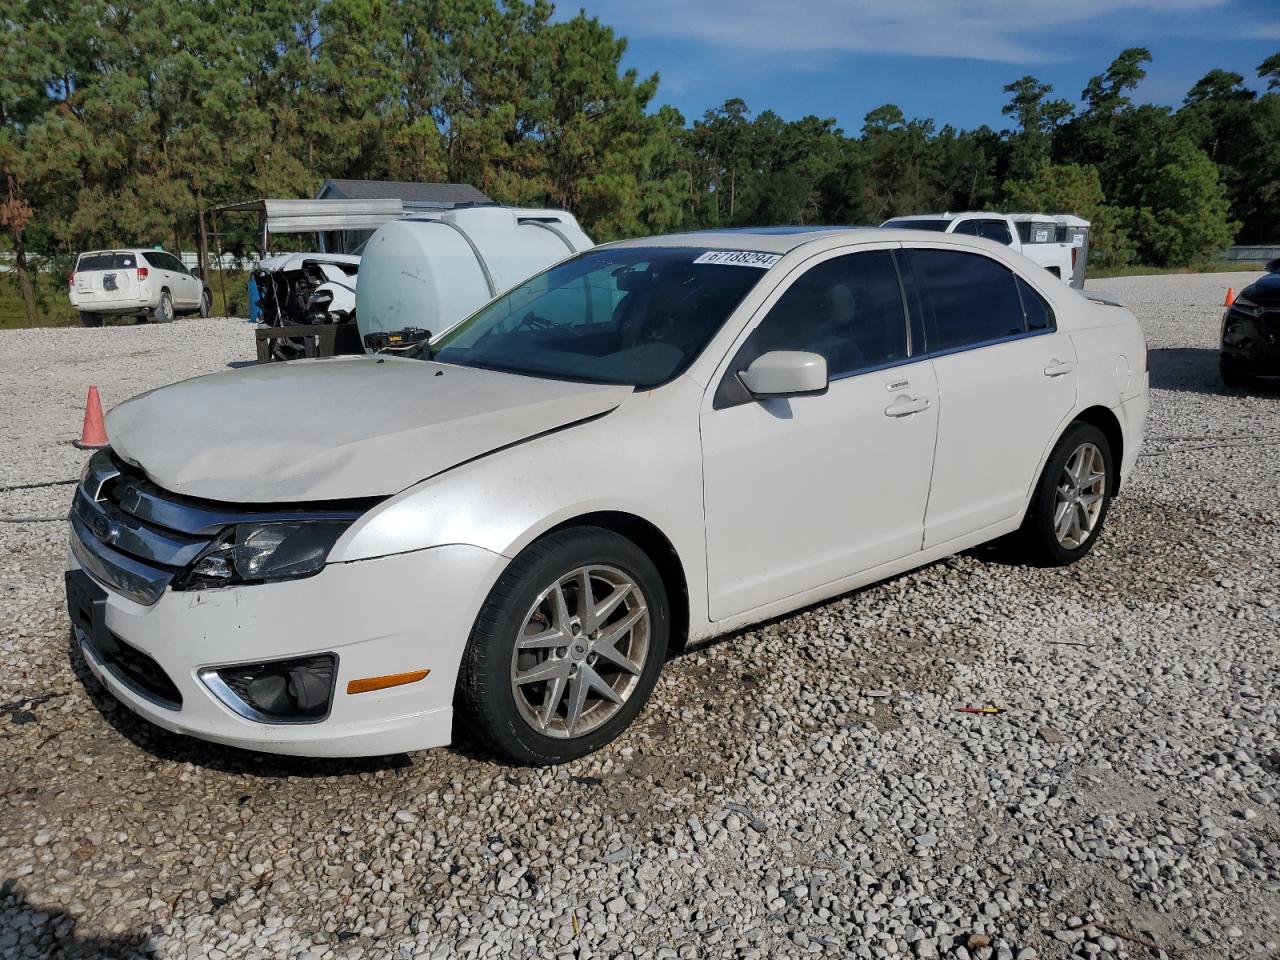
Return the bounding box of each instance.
[559,0,1280,133]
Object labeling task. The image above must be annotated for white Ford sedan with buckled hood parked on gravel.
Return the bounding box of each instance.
[67,229,1147,763]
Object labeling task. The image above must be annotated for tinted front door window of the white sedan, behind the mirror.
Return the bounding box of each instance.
[735,250,906,380]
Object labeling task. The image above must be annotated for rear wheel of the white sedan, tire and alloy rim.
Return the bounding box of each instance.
[1020,422,1115,567]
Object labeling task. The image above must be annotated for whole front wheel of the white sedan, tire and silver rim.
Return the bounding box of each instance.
[457,527,671,764]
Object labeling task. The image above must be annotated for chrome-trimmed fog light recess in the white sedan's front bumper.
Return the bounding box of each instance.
[200,653,338,723]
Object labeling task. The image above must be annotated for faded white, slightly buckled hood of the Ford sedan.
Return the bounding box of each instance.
[106,357,631,503]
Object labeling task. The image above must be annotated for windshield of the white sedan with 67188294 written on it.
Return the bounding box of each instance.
[431,247,781,388]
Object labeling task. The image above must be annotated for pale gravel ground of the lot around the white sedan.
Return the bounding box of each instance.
[0,274,1280,960]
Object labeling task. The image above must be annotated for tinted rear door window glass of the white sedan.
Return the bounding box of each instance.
[910,250,1027,351]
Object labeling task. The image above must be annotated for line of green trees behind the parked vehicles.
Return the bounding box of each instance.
[0,0,1280,319]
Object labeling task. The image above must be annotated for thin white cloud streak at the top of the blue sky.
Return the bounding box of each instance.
[586,0,1230,68]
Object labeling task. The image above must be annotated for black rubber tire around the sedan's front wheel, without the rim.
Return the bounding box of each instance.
[457,527,671,764]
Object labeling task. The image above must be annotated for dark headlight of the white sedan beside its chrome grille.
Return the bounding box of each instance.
[180,520,351,589]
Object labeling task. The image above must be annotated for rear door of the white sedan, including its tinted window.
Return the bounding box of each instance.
[904,247,1075,548]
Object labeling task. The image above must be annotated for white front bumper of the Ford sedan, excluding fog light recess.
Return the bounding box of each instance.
[69,545,507,756]
